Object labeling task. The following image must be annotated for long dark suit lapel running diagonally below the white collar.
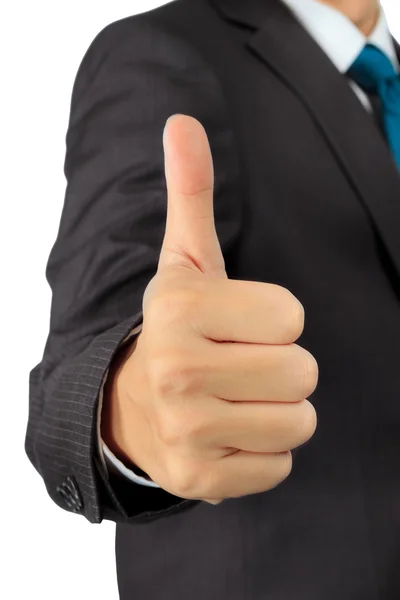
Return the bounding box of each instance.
[213,0,400,275]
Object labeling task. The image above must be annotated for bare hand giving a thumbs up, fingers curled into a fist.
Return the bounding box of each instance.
[106,115,318,504]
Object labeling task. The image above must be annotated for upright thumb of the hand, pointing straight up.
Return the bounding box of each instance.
[158,114,227,277]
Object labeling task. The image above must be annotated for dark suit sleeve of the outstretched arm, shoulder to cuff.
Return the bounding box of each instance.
[25,15,244,523]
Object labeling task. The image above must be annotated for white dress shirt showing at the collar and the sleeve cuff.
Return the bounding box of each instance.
[97,0,400,487]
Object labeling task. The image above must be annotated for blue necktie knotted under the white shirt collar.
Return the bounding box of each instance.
[347,44,400,169]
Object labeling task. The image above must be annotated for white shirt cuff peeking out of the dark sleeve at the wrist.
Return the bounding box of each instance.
[97,323,160,488]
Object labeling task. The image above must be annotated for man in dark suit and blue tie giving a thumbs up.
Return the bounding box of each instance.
[26,0,400,600]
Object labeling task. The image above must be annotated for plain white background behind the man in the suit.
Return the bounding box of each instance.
[0,0,400,600]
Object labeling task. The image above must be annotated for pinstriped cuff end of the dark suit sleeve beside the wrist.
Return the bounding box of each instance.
[25,312,142,523]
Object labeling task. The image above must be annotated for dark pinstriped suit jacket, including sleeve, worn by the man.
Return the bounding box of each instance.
[26,0,400,600]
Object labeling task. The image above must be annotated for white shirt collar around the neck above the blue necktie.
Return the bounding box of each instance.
[283,0,400,73]
